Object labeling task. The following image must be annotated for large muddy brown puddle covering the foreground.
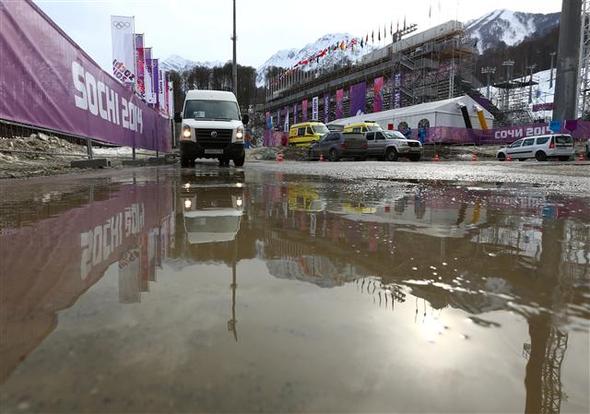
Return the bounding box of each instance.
[0,167,590,413]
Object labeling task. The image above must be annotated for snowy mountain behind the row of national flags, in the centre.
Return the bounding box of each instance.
[256,33,374,86]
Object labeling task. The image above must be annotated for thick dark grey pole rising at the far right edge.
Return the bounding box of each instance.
[553,0,582,121]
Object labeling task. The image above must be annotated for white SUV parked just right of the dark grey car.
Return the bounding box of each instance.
[365,131,423,161]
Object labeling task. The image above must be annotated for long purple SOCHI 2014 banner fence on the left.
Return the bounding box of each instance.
[0,0,171,152]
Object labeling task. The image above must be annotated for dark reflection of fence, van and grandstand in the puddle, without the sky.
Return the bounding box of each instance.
[0,169,590,413]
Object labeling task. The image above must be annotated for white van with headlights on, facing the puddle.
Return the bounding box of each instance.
[174,90,249,167]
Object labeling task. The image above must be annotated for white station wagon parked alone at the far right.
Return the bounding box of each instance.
[497,134,575,161]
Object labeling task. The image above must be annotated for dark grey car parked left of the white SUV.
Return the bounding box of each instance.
[309,132,368,161]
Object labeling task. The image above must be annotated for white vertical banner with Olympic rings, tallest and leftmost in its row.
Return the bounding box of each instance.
[111,16,136,84]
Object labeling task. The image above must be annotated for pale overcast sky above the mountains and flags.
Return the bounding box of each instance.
[34,0,561,70]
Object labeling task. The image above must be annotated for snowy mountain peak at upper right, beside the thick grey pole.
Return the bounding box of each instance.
[466,10,560,53]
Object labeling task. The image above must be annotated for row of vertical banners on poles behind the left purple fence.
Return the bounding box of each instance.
[111,16,174,117]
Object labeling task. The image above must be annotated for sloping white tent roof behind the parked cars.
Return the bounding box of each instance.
[330,95,494,125]
